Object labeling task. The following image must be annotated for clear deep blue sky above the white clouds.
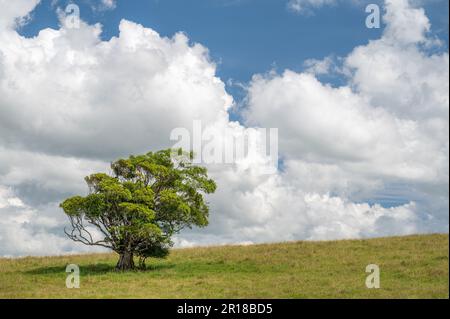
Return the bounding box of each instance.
[20,0,449,101]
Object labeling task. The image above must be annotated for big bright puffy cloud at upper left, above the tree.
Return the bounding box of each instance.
[0,20,232,160]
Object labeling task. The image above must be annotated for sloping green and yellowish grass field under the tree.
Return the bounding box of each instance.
[0,235,449,298]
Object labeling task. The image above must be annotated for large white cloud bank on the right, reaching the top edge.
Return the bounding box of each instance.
[239,0,449,242]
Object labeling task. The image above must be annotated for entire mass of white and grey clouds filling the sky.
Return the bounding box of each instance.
[0,0,449,255]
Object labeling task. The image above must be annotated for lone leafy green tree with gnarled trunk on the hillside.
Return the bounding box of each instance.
[60,149,216,270]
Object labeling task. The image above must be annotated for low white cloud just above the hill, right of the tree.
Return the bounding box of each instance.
[183,165,424,248]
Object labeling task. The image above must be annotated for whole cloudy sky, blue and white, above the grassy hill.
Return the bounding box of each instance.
[0,0,449,256]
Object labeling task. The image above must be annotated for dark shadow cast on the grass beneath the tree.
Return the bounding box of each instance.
[24,263,175,275]
